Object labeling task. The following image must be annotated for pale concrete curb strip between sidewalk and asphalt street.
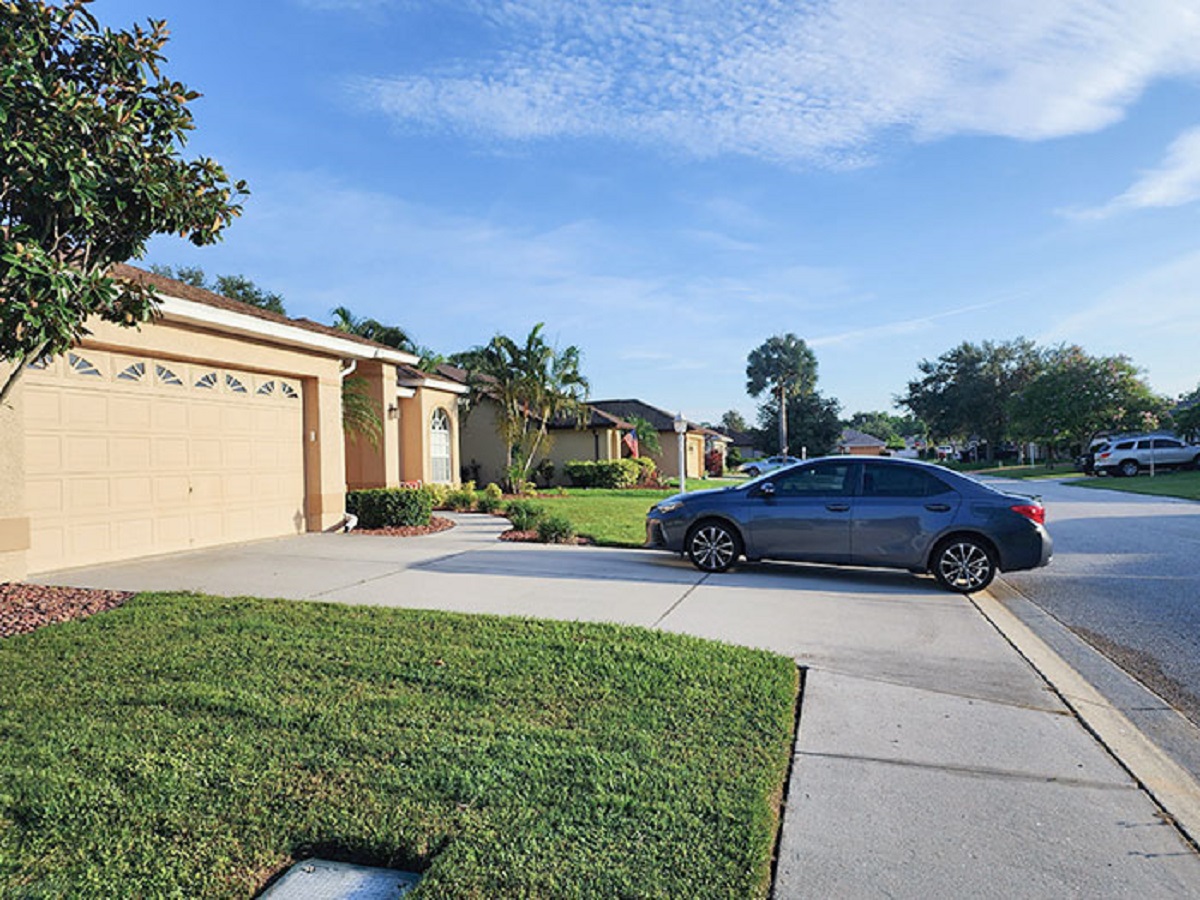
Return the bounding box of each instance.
[967,581,1200,846]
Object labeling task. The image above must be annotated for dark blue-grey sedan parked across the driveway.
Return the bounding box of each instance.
[646,456,1054,593]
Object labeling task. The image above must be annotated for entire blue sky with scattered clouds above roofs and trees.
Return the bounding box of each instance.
[100,0,1200,420]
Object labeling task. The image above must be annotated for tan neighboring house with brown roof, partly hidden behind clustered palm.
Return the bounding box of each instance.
[448,366,634,485]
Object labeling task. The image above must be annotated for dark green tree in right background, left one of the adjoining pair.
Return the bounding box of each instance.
[896,337,1044,460]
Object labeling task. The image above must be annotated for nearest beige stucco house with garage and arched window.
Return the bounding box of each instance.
[0,265,458,582]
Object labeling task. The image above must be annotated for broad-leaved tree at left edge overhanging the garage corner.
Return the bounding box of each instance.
[0,0,247,401]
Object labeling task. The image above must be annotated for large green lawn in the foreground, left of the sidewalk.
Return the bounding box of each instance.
[0,594,797,898]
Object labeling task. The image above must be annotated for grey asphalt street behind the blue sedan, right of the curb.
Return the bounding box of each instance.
[997,475,1200,725]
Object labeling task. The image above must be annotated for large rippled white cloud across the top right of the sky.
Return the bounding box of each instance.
[343,0,1200,166]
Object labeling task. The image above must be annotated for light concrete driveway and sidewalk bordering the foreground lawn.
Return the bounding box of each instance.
[32,516,1200,898]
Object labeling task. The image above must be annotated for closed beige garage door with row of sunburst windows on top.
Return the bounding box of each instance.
[24,349,305,572]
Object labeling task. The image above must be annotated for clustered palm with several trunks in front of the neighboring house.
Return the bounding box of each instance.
[455,323,588,491]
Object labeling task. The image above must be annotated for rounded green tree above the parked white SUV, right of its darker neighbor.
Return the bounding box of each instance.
[1010,346,1168,449]
